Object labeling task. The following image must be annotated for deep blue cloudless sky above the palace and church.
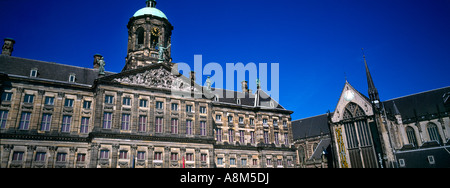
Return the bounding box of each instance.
[0,0,450,120]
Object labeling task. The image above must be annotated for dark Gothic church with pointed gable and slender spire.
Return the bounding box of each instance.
[292,52,450,168]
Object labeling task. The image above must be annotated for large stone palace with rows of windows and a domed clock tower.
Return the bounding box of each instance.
[0,0,297,168]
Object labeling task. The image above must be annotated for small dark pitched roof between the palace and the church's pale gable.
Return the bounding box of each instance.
[292,114,330,140]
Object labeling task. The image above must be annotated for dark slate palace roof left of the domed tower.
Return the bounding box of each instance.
[0,55,114,85]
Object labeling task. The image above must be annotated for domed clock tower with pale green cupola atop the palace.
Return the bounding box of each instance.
[122,0,173,71]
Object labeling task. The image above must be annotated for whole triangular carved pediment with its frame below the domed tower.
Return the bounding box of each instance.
[102,64,199,92]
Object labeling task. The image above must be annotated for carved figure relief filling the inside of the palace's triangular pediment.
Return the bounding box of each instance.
[112,66,198,92]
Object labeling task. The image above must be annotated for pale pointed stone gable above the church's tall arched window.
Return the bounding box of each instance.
[331,82,373,123]
